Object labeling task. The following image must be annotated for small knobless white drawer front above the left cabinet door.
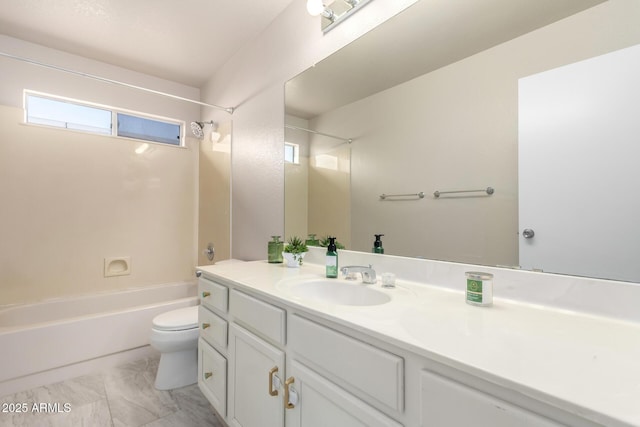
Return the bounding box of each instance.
[229,289,286,344]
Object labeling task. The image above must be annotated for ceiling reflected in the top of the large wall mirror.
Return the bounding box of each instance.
[286,0,605,119]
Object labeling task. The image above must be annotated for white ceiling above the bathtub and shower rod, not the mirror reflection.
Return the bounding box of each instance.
[0,0,294,87]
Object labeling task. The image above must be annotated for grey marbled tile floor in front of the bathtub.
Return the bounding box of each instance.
[0,358,225,427]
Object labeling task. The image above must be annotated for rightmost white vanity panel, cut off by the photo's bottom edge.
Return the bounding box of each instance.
[420,371,562,427]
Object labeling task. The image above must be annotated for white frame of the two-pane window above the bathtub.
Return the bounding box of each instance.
[23,89,186,148]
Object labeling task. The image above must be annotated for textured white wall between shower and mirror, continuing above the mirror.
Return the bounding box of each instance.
[202,0,415,259]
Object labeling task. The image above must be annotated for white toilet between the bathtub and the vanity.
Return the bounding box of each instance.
[150,305,200,390]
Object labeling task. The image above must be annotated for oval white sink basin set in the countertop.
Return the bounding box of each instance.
[288,279,391,306]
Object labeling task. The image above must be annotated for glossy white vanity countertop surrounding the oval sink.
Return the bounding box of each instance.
[198,261,640,426]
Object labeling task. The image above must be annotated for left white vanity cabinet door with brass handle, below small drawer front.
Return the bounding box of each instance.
[228,323,284,427]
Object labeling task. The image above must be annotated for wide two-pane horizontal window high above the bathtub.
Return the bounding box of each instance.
[25,93,183,146]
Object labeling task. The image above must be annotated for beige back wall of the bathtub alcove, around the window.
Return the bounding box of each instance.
[0,36,200,305]
